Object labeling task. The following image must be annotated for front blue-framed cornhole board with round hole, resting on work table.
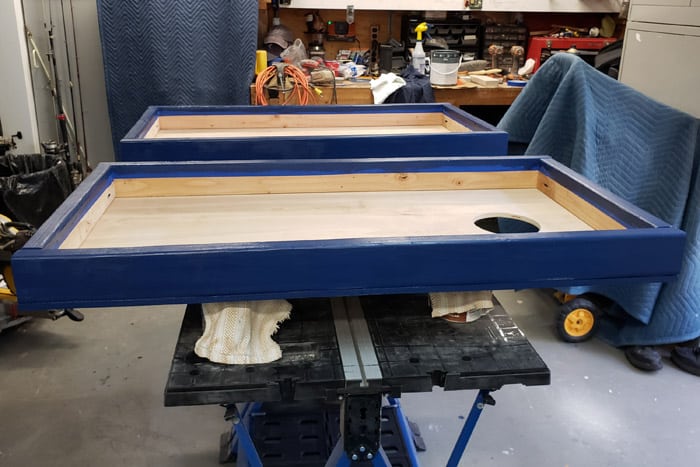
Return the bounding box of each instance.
[12,156,685,310]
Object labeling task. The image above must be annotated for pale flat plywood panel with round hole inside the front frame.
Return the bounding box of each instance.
[74,189,592,248]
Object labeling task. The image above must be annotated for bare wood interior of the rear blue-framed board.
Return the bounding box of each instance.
[144,112,470,139]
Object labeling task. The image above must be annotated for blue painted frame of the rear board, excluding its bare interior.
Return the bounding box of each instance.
[120,104,508,161]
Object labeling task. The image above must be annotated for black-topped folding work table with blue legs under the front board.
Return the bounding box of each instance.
[165,295,549,467]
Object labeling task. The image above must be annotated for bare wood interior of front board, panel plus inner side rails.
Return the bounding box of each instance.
[61,171,624,249]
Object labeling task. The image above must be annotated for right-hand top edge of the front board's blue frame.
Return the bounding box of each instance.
[541,158,672,228]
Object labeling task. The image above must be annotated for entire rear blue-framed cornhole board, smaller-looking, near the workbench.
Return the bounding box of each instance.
[119,104,508,162]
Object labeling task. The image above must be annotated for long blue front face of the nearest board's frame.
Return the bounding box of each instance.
[13,229,684,310]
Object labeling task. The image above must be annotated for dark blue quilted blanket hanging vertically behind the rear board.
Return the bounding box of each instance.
[97,0,258,159]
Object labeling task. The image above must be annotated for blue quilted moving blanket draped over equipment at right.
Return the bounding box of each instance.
[498,54,700,345]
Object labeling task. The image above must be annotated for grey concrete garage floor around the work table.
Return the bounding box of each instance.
[0,290,700,467]
